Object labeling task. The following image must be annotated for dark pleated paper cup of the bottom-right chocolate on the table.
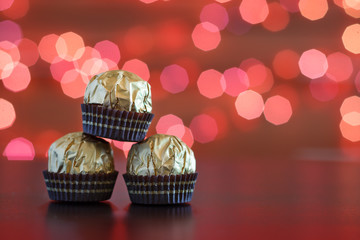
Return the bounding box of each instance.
[123,173,198,205]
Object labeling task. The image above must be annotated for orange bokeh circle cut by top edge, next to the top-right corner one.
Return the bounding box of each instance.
[299,0,329,21]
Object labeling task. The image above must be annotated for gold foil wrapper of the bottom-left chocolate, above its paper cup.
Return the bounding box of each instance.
[48,132,114,174]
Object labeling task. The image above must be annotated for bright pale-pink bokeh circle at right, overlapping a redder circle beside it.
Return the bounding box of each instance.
[299,49,328,79]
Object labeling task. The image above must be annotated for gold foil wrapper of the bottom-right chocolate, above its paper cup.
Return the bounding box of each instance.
[126,134,196,176]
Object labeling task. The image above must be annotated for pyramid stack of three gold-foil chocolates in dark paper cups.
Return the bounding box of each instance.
[43,70,198,204]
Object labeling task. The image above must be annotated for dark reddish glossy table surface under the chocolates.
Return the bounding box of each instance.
[0,158,360,240]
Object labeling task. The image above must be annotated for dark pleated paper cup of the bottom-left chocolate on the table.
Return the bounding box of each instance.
[43,170,118,202]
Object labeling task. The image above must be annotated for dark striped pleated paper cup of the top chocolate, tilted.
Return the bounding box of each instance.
[81,104,154,142]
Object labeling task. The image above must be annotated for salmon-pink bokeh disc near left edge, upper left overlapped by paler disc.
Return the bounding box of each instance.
[2,63,31,92]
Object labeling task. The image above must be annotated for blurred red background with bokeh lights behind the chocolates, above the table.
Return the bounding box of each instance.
[0,0,360,161]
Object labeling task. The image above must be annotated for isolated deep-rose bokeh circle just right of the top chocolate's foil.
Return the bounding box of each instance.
[160,64,189,94]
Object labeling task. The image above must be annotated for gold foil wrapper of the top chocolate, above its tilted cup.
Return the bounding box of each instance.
[84,70,152,113]
